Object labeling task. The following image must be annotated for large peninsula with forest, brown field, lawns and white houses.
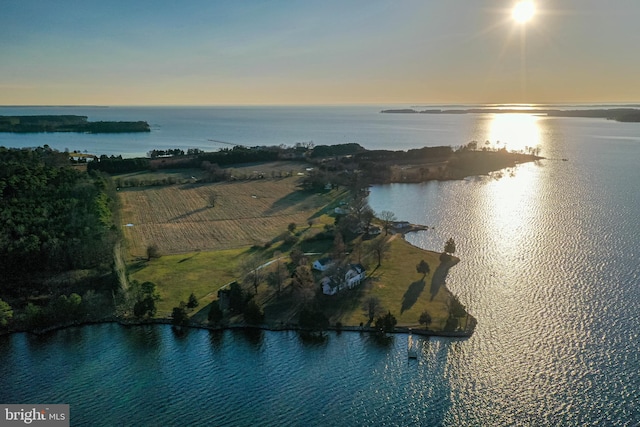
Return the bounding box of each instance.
[0,144,540,336]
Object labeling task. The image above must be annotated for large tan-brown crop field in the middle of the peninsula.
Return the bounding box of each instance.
[119,172,345,258]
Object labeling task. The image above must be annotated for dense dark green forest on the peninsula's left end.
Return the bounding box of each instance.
[0,147,117,296]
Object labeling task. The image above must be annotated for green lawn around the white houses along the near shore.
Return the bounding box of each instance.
[129,234,460,330]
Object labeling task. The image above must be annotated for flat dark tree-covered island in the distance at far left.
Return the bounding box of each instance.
[0,115,151,133]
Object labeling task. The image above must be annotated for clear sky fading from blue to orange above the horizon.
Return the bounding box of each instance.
[0,0,640,105]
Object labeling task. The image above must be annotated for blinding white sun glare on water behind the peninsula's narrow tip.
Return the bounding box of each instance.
[489,113,542,152]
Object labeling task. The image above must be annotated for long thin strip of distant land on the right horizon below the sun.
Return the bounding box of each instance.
[381,108,640,122]
